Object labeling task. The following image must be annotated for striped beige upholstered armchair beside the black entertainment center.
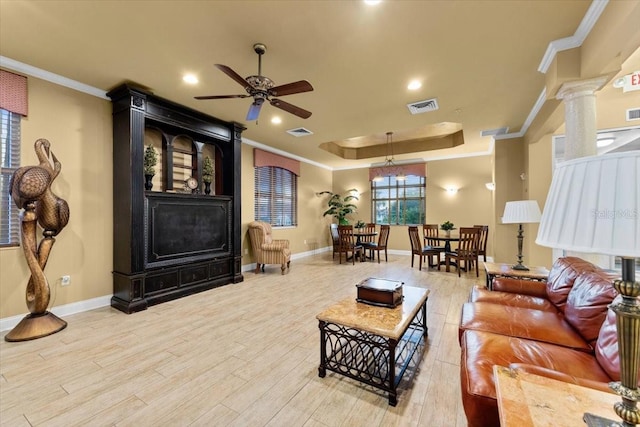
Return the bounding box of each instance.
[249,221,291,274]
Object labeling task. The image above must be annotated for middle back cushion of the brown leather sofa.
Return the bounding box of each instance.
[564,272,618,345]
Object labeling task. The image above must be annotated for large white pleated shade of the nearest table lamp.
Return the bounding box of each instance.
[536,151,640,258]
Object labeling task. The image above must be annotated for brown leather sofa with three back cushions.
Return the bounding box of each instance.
[459,257,632,427]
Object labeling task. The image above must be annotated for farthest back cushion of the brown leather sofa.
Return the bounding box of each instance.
[547,257,600,313]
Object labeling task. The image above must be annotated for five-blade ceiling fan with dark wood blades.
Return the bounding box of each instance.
[195,43,313,121]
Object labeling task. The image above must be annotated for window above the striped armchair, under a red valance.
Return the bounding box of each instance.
[255,166,298,227]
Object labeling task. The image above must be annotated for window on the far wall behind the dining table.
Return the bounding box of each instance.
[371,175,426,225]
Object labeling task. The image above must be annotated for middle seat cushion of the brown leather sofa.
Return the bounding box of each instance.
[459,302,593,353]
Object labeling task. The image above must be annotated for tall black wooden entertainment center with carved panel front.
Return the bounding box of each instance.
[107,84,245,313]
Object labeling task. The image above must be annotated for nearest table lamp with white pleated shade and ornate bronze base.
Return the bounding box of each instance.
[536,151,640,427]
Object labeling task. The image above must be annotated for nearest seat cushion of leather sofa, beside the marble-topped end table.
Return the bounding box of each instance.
[460,330,611,427]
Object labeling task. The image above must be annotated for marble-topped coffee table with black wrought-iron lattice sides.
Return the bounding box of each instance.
[316,286,429,406]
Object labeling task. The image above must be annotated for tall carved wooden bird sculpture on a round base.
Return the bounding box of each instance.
[5,139,69,341]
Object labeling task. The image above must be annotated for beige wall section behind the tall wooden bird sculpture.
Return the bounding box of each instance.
[0,78,113,318]
